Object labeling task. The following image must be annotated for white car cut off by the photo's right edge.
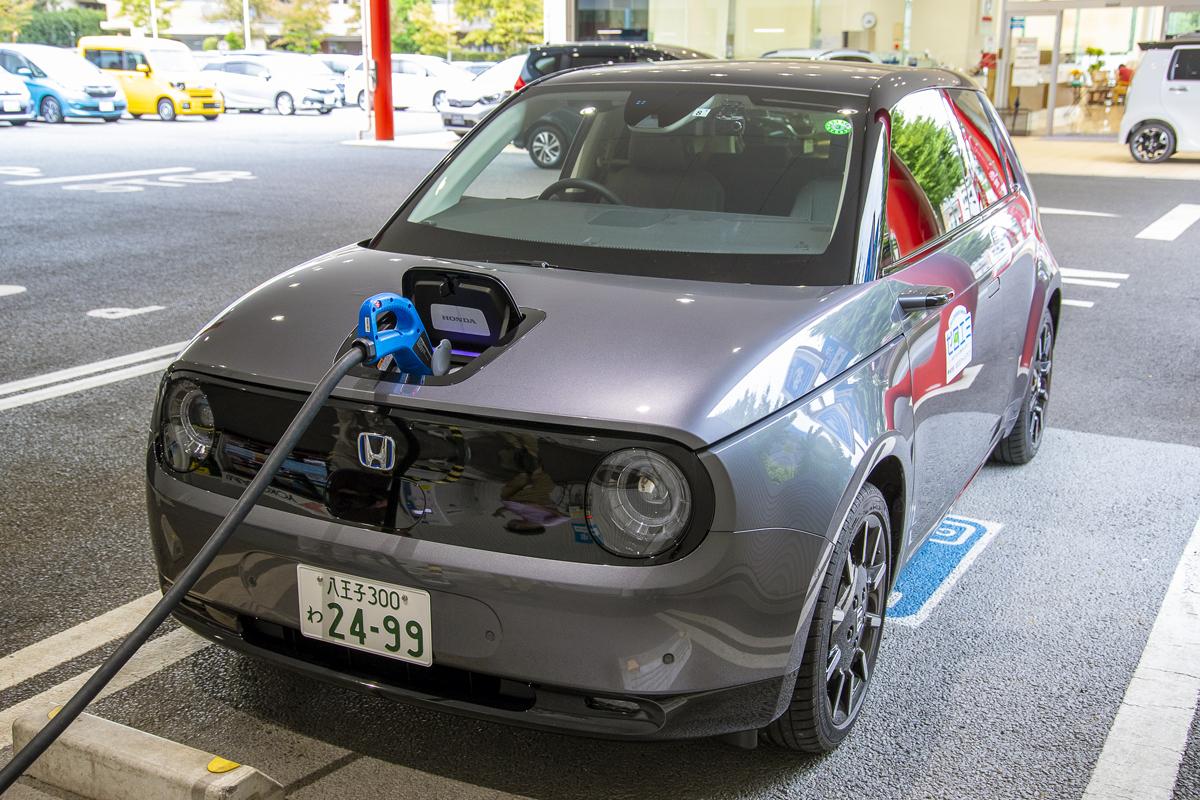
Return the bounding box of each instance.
[1118,34,1200,164]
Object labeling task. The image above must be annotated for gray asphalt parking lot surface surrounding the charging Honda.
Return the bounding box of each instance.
[0,109,1200,800]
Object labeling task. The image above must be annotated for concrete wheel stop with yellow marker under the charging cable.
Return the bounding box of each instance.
[12,709,283,800]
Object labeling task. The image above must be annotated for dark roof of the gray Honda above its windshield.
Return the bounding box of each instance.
[538,59,978,108]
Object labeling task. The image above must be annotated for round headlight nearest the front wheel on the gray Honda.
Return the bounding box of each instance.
[586,447,692,558]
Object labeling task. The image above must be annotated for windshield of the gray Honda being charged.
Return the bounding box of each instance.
[376,83,863,285]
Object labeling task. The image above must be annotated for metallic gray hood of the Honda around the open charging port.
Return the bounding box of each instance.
[176,246,899,447]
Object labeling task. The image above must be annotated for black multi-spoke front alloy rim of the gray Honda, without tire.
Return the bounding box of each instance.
[824,513,888,728]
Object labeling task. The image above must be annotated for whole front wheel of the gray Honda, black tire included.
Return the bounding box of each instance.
[763,483,892,753]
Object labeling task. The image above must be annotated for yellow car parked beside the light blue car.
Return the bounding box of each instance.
[79,36,224,122]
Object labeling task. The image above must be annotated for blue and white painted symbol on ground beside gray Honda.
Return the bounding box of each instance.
[888,517,1000,625]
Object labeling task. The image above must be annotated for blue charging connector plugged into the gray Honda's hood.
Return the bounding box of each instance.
[356,291,450,377]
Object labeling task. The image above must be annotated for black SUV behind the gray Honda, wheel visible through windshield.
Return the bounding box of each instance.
[512,42,713,169]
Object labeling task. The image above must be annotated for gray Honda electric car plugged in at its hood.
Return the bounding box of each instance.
[146,60,1060,751]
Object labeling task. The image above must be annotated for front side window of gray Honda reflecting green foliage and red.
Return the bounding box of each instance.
[887,89,980,258]
